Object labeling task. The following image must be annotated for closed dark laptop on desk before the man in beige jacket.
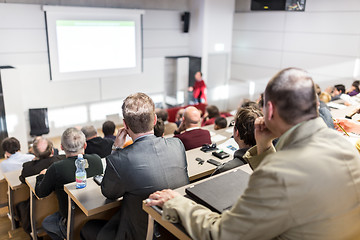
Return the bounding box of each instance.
[185,169,250,213]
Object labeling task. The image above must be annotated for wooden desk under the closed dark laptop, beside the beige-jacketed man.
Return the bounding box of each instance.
[143,164,252,240]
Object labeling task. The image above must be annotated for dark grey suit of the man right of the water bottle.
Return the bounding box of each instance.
[97,134,189,240]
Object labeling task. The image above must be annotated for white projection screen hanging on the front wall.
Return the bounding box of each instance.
[43,6,144,81]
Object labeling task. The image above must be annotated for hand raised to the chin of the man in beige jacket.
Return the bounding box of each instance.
[254,117,276,154]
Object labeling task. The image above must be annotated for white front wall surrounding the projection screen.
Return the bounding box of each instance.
[0,4,189,148]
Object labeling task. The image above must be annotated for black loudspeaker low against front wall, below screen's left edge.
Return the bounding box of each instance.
[29,108,49,136]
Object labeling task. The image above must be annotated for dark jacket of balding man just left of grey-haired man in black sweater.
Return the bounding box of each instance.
[19,155,66,183]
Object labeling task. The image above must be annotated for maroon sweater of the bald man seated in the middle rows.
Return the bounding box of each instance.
[174,128,211,151]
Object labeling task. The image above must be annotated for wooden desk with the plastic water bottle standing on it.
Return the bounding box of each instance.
[64,177,121,240]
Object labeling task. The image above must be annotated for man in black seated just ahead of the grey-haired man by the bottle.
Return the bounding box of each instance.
[81,126,114,158]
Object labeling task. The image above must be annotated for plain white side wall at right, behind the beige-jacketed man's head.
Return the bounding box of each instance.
[229,0,360,107]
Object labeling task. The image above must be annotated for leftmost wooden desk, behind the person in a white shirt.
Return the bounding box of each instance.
[4,170,29,230]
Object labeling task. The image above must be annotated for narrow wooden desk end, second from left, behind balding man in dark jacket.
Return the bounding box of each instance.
[25,175,59,240]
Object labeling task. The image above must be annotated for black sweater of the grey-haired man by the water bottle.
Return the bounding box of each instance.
[35,154,103,218]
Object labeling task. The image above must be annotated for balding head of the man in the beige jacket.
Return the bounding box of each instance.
[265,68,318,125]
